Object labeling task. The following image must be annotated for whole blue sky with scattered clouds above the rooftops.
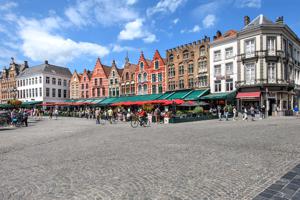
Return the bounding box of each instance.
[0,0,300,71]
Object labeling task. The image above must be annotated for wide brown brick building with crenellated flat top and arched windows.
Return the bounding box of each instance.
[166,36,210,91]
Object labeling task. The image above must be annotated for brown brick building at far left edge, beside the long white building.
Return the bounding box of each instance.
[0,58,28,103]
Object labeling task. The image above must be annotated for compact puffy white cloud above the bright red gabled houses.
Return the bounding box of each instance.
[118,18,156,43]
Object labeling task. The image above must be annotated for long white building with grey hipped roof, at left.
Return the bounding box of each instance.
[17,61,72,102]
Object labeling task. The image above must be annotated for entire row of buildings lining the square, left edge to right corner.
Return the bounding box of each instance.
[0,15,300,113]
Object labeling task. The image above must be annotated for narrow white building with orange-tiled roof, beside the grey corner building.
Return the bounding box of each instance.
[210,30,237,93]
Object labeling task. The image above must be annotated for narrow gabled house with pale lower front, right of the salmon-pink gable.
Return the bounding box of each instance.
[108,60,123,97]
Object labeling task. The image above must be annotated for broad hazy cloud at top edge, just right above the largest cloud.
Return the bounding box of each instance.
[65,0,138,27]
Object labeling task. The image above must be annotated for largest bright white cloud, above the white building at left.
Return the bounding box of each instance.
[18,17,109,64]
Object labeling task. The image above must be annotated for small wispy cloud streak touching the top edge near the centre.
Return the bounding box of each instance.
[147,0,186,16]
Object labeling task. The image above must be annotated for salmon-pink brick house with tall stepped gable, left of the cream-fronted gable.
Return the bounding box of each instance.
[90,58,111,97]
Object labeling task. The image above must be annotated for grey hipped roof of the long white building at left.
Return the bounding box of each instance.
[20,63,72,77]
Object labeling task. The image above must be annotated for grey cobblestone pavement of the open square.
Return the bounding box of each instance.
[0,117,300,200]
